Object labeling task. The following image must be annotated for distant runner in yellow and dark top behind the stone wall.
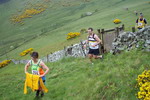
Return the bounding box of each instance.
[136,13,147,30]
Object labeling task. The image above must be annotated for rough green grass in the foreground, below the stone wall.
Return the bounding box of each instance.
[0,50,150,100]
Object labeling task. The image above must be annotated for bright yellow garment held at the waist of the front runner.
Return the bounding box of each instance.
[24,73,48,94]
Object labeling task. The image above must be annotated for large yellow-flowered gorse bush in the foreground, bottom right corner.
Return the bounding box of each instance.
[136,70,150,100]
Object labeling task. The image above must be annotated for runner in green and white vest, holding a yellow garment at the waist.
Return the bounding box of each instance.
[25,52,49,97]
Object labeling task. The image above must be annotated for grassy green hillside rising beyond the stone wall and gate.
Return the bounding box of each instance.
[0,0,150,60]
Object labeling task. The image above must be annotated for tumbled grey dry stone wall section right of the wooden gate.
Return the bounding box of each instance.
[110,26,150,54]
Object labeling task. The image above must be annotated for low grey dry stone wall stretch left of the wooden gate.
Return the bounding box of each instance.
[12,41,88,64]
